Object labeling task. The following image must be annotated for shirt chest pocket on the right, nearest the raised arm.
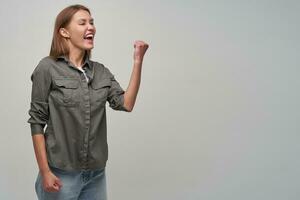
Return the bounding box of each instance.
[91,78,111,103]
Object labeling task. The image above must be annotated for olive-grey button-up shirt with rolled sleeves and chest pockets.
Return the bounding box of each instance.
[27,56,129,171]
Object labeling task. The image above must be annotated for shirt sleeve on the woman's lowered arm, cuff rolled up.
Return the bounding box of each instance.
[27,61,51,135]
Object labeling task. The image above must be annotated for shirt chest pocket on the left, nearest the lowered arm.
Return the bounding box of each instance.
[54,78,79,106]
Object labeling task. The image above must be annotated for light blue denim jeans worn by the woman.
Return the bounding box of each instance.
[35,166,107,200]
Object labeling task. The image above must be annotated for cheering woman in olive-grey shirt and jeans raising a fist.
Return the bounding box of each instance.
[28,5,148,200]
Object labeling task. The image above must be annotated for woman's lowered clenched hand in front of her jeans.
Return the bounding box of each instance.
[42,171,62,192]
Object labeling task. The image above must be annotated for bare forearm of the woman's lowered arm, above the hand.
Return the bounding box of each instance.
[32,134,50,174]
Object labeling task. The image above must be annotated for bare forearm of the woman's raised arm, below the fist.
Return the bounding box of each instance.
[124,59,143,111]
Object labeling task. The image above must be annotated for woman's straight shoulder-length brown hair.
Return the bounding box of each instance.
[49,4,91,58]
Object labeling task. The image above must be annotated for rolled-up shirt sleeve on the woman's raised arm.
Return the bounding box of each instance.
[106,68,129,112]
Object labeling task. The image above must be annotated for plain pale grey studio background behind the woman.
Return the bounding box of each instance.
[0,0,300,200]
